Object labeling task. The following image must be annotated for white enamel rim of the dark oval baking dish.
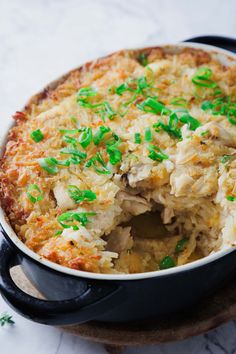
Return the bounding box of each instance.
[0,42,236,281]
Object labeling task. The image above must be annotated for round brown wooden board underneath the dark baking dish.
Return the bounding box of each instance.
[11,266,236,354]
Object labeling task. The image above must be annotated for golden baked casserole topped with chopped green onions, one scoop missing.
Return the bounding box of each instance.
[0,48,236,273]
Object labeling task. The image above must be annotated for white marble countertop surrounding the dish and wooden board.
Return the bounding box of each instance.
[0,0,236,354]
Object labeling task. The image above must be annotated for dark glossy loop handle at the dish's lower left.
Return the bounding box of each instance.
[0,237,124,326]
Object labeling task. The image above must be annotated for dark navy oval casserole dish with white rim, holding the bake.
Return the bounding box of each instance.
[0,40,236,325]
